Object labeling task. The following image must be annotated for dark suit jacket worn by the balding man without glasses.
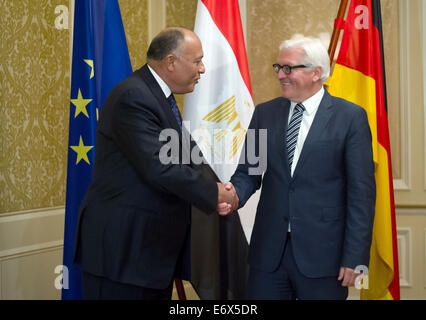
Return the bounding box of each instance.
[75,65,218,289]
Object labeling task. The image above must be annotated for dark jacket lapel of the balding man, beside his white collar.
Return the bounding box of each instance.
[138,64,182,137]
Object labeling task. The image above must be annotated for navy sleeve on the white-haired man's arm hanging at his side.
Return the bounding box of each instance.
[342,108,376,268]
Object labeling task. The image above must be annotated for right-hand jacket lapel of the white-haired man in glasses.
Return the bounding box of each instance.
[293,90,333,179]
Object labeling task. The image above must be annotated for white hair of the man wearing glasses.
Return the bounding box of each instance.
[280,35,330,83]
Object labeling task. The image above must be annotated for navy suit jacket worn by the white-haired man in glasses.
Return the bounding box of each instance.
[231,92,376,278]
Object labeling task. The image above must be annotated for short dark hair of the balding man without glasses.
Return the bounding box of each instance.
[146,29,185,61]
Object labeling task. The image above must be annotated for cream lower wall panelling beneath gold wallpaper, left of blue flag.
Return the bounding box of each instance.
[0,207,65,300]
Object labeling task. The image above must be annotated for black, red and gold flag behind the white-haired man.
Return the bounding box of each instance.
[328,0,400,300]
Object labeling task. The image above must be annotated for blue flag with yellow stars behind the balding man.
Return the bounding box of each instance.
[62,0,132,300]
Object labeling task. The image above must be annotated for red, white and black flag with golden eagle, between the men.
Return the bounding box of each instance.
[183,0,255,299]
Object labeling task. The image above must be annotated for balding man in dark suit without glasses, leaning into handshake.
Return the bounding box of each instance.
[75,28,238,299]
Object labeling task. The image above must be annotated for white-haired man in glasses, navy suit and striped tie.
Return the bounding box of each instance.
[219,38,376,299]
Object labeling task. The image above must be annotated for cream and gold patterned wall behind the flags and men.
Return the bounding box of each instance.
[0,0,426,299]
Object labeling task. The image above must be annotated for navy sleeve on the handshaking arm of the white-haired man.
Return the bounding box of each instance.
[230,107,265,208]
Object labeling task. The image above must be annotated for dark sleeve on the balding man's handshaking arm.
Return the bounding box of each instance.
[112,89,218,212]
